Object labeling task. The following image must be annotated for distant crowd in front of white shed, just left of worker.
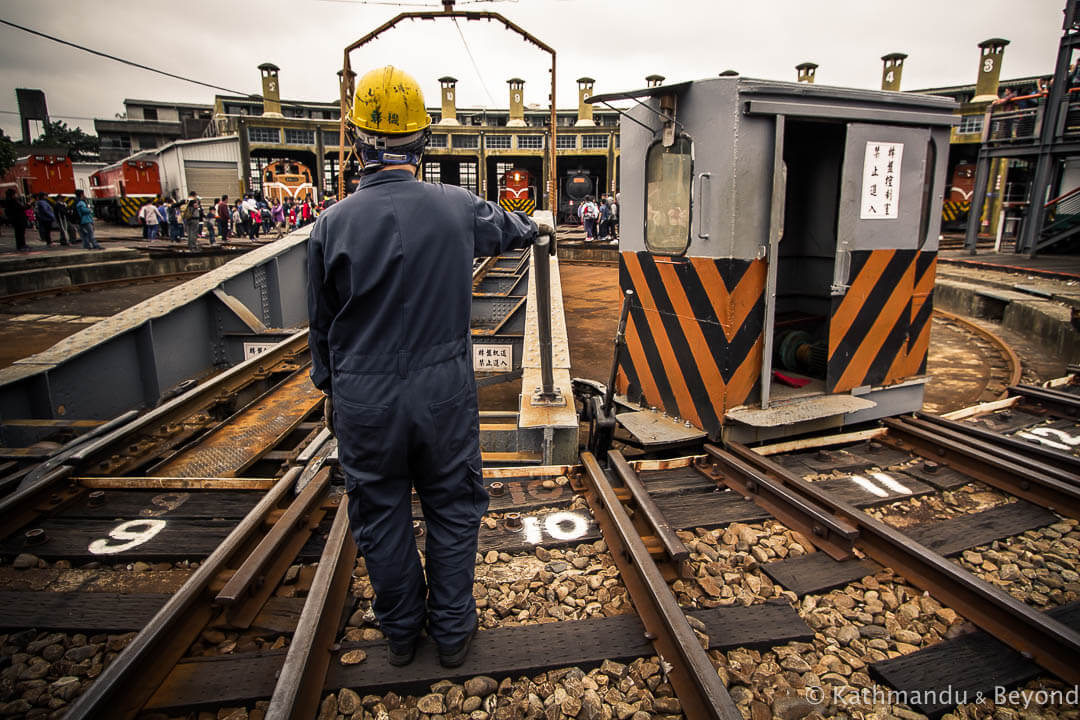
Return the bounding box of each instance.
[137,190,335,249]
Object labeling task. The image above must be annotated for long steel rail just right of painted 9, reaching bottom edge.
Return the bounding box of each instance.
[65,467,301,720]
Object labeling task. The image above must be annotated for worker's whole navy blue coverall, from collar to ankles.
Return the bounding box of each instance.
[308,169,537,648]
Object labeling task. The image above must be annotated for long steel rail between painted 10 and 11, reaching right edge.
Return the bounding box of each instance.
[705,443,1080,683]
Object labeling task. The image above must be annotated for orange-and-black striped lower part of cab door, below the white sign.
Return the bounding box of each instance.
[826,249,936,393]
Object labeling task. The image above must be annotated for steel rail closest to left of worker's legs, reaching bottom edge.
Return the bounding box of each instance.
[267,495,356,720]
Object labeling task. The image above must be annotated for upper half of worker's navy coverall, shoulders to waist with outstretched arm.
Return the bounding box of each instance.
[309,169,534,389]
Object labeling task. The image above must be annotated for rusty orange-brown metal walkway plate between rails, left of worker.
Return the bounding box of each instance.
[153,372,323,477]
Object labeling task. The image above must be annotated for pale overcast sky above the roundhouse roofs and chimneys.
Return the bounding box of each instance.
[0,0,1065,142]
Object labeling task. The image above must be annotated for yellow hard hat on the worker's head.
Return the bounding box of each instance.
[349,65,431,135]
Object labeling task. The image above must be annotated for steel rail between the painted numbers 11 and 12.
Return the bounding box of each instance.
[879,418,1080,518]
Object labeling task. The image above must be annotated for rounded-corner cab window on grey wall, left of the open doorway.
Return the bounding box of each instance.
[645,136,693,255]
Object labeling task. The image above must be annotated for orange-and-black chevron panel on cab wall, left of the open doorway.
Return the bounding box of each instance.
[617,253,766,436]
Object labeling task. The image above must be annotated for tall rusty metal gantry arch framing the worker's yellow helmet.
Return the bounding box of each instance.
[338,0,558,212]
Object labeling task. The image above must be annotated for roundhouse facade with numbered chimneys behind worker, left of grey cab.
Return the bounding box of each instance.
[206,63,619,208]
